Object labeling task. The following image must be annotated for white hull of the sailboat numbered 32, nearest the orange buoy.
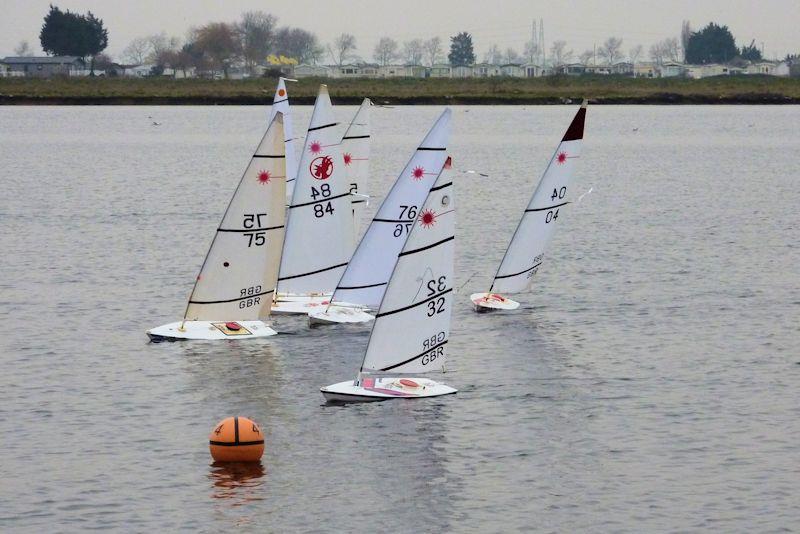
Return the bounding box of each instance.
[320,377,458,402]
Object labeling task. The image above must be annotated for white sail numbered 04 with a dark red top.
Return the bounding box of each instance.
[490,101,586,293]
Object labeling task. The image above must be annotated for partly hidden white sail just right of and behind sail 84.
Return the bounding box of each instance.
[342,98,372,236]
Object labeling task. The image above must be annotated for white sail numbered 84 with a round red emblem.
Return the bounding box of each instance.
[278,85,354,295]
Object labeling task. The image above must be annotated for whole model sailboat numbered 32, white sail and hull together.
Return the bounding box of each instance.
[321,152,456,402]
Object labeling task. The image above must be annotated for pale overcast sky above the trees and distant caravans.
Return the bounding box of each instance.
[0,0,800,59]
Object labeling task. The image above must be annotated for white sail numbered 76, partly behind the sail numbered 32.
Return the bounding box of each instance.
[331,109,452,309]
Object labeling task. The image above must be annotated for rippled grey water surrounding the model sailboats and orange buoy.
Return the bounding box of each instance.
[0,106,800,532]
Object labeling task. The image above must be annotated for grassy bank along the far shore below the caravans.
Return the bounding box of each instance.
[0,76,800,104]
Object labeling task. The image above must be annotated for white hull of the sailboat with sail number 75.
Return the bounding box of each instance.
[147,321,277,342]
